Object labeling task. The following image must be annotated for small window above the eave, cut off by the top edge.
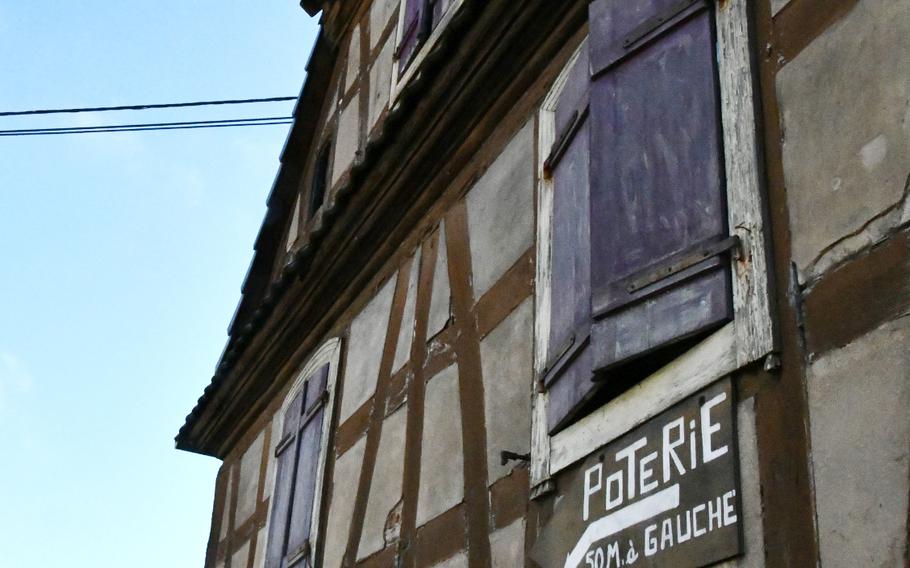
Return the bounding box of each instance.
[393,0,463,89]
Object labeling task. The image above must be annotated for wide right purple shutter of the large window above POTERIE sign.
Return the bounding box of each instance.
[589,0,732,374]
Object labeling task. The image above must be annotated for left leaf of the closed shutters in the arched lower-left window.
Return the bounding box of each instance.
[265,391,303,568]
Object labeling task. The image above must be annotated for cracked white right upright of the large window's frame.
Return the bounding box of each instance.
[716,0,775,365]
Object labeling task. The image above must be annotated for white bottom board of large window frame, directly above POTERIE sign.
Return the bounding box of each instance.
[549,324,737,475]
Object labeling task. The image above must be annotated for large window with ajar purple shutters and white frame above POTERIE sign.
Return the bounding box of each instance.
[532,0,773,488]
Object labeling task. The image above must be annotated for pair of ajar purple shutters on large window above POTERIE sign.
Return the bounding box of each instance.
[544,2,734,430]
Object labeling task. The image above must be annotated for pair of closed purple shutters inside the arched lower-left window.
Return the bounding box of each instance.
[266,364,329,568]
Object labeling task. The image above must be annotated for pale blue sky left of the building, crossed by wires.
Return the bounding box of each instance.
[0,0,316,568]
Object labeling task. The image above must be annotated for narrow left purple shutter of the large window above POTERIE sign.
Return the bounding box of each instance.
[543,44,598,433]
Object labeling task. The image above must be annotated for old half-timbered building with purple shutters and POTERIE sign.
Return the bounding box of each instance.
[176,0,910,568]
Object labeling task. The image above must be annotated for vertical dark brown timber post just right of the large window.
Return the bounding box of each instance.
[746,0,824,566]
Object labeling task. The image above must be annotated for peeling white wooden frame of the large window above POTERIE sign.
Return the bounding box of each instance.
[531,0,776,497]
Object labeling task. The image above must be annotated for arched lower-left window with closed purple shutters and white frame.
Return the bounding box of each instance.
[265,339,341,568]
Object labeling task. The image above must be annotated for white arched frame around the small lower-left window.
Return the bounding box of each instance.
[256,337,342,566]
